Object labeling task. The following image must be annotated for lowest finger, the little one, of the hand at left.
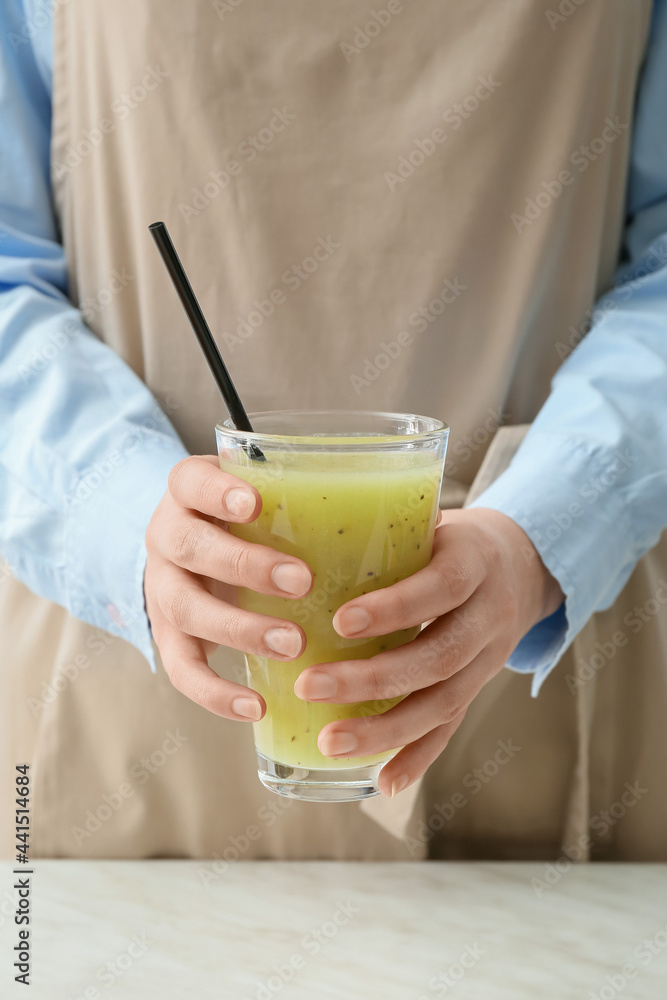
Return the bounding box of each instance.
[155,621,266,722]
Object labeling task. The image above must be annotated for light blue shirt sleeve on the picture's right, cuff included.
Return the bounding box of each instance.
[471,0,667,695]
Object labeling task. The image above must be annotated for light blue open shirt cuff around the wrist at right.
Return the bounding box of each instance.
[470,430,637,697]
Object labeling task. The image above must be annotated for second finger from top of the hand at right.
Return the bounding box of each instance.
[294,591,493,704]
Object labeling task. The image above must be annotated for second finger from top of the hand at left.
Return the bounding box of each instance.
[158,510,313,597]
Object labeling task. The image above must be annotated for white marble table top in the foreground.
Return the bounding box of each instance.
[0,861,667,1000]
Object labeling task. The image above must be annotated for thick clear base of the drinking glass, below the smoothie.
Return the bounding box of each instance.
[257,752,386,802]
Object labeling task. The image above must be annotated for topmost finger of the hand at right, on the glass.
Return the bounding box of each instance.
[333,525,487,638]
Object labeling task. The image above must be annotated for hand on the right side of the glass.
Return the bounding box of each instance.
[294,508,563,795]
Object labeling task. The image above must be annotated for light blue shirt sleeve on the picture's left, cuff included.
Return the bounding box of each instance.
[0,0,187,669]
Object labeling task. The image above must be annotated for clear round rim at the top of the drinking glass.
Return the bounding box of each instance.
[215,410,450,451]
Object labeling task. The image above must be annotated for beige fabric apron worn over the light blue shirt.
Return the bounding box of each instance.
[0,0,667,867]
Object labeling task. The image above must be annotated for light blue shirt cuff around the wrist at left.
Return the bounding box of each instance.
[66,429,188,673]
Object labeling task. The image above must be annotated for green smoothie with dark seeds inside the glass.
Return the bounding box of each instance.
[220,451,442,769]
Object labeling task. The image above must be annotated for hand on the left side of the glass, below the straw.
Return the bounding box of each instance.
[144,455,313,722]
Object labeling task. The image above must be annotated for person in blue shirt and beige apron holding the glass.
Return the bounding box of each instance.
[0,0,667,858]
